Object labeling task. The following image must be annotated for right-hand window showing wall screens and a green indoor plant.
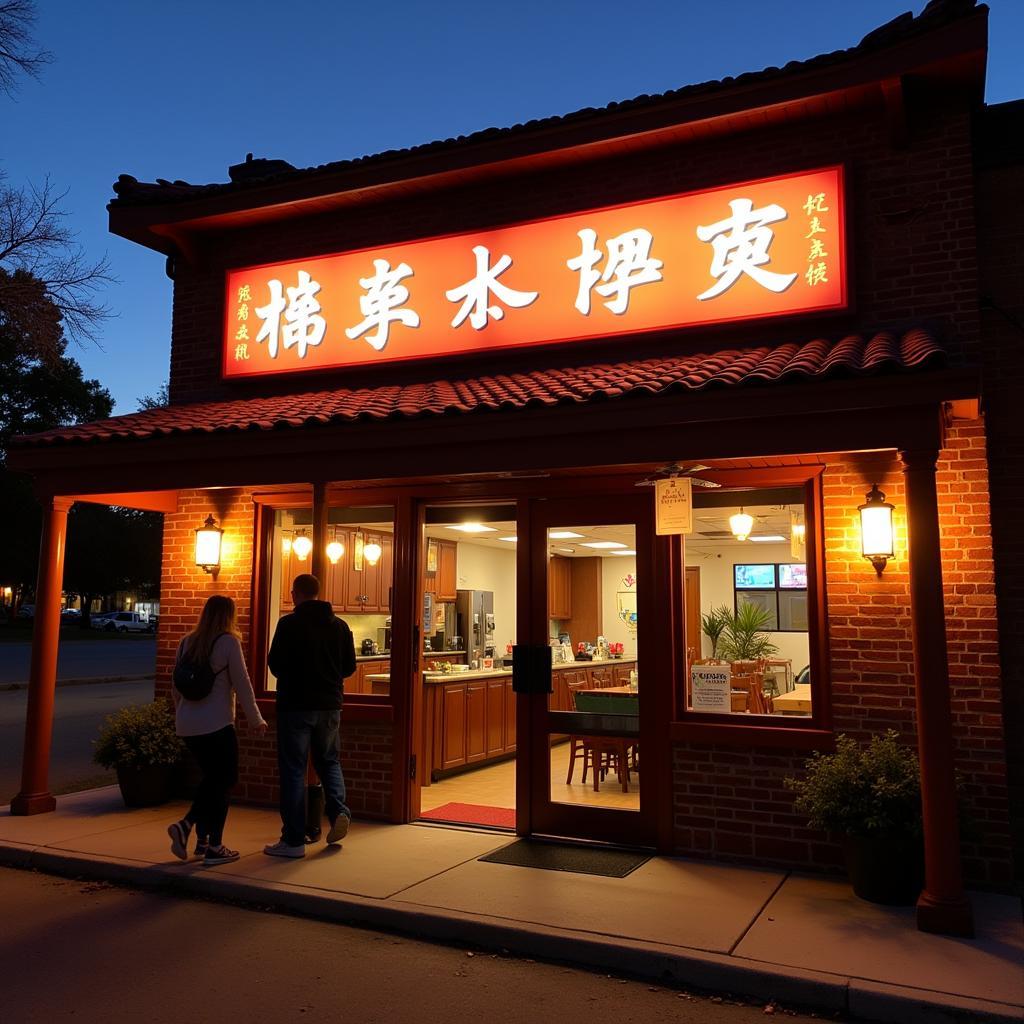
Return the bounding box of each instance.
[684,485,811,724]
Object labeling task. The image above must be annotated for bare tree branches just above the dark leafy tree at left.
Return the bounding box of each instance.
[0,169,116,343]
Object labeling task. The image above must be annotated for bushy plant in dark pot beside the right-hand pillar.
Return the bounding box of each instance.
[785,729,924,905]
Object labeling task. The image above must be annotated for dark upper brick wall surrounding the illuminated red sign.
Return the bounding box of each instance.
[170,97,978,402]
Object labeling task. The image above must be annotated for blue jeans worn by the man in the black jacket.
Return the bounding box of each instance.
[278,711,351,846]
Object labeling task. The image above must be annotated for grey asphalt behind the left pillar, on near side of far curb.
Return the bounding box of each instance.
[0,679,153,798]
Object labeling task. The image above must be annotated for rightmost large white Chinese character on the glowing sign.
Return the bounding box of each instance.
[697,199,797,301]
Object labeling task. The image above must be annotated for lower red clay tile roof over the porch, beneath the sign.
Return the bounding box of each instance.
[11,328,945,447]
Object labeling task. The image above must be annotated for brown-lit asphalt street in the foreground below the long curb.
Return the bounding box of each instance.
[0,868,784,1024]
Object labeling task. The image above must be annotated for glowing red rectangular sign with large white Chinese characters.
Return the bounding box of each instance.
[223,168,847,377]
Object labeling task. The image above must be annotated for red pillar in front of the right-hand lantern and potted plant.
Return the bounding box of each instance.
[900,451,974,936]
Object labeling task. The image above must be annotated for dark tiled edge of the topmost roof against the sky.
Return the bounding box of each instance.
[111,0,976,206]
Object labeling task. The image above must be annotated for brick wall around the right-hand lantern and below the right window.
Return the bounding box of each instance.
[674,421,1011,887]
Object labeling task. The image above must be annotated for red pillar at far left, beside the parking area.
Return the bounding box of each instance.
[10,498,74,814]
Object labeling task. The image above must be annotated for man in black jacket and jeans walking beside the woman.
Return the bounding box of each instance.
[263,573,355,857]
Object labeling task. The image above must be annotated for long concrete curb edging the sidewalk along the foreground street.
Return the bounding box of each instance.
[0,843,1024,1024]
